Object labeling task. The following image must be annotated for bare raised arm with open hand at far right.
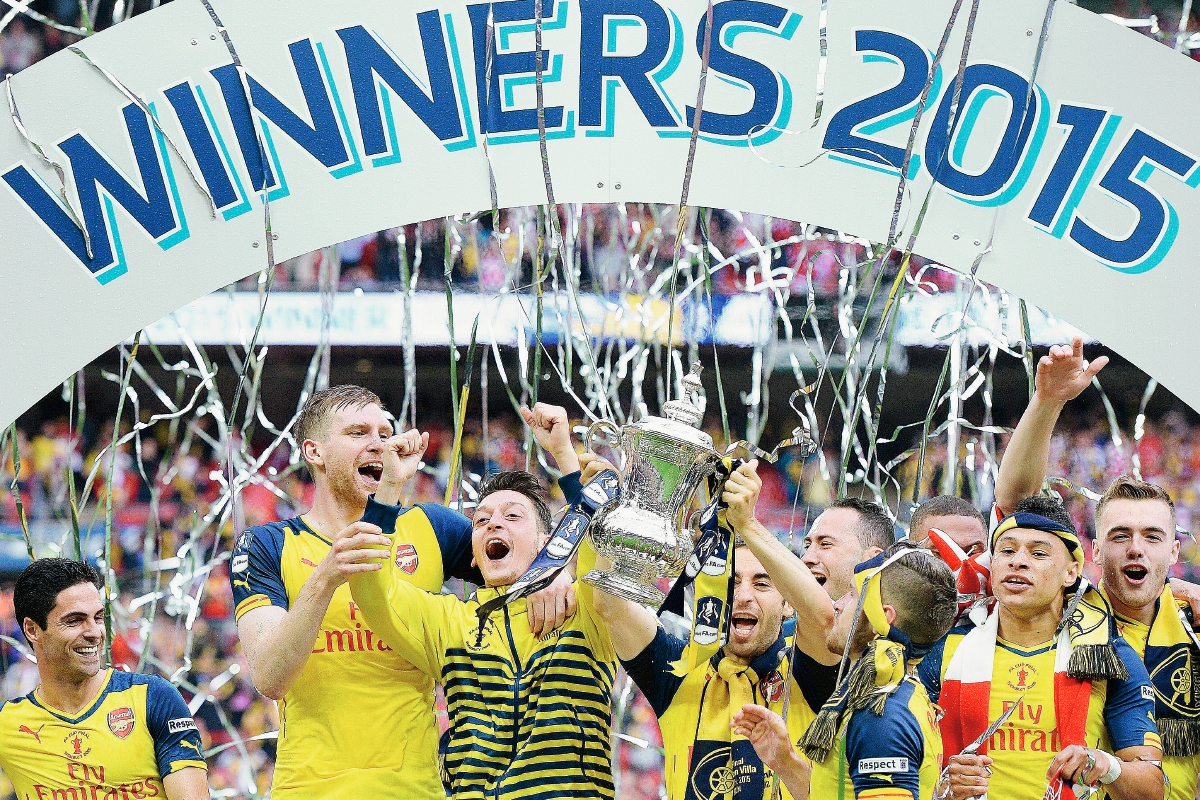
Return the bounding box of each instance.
[996,336,1109,513]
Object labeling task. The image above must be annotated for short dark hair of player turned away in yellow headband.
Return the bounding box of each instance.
[880,543,959,644]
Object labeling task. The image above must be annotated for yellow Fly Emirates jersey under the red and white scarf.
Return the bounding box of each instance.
[918,628,1162,800]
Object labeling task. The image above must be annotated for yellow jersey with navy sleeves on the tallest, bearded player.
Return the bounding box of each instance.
[230,504,481,800]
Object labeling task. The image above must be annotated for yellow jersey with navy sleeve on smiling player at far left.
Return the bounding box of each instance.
[0,669,205,800]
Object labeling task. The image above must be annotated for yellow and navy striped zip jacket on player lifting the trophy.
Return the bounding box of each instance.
[350,500,617,800]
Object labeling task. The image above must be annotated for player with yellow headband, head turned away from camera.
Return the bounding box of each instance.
[734,545,958,800]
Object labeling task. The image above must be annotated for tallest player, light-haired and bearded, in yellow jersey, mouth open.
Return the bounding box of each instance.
[230,386,574,800]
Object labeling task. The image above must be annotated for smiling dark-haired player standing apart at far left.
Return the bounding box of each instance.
[0,558,209,800]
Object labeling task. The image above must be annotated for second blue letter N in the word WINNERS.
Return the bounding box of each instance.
[337,16,462,146]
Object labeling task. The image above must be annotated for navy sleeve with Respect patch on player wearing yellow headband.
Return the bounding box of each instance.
[846,684,925,798]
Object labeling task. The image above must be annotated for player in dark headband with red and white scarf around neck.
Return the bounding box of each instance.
[919,498,1163,800]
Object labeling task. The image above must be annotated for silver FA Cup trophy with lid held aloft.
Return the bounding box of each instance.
[583,365,721,607]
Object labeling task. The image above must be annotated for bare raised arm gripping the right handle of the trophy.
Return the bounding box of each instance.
[721,459,839,664]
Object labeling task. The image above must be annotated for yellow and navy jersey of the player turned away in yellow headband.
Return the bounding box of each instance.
[809,673,945,800]
